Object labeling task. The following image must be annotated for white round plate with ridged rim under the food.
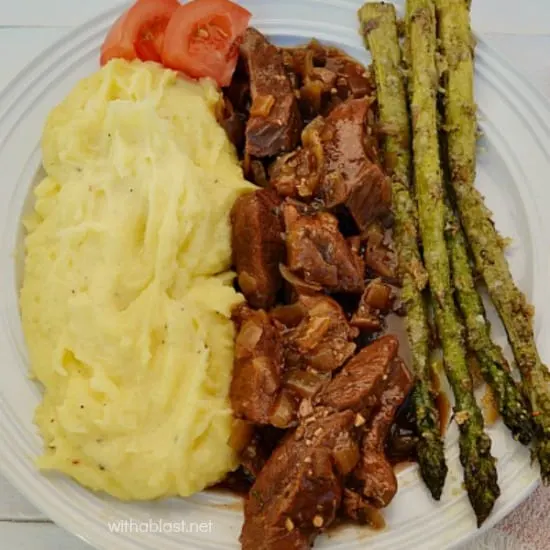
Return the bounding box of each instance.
[0,0,550,550]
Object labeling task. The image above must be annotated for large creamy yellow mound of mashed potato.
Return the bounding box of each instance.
[21,60,251,499]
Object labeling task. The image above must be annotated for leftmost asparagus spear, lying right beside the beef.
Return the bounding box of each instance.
[359,3,447,500]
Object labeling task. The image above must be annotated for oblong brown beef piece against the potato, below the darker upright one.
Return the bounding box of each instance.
[230,310,284,424]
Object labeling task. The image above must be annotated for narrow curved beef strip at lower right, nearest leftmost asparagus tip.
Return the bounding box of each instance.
[353,358,413,508]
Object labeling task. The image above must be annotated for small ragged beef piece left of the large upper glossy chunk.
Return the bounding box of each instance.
[269,148,319,200]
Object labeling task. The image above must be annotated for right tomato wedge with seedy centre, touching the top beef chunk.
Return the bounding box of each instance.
[162,0,251,86]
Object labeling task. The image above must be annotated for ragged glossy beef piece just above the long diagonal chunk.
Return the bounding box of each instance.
[285,295,359,372]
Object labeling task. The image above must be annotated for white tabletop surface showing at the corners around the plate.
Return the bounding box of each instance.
[0,0,550,550]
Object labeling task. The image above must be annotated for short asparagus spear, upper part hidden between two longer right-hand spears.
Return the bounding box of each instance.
[447,207,533,445]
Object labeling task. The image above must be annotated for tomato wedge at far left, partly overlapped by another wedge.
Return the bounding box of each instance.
[100,0,180,65]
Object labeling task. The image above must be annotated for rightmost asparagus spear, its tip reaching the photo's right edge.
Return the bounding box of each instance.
[437,0,550,484]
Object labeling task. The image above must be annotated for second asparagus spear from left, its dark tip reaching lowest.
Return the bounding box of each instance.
[407,0,500,525]
